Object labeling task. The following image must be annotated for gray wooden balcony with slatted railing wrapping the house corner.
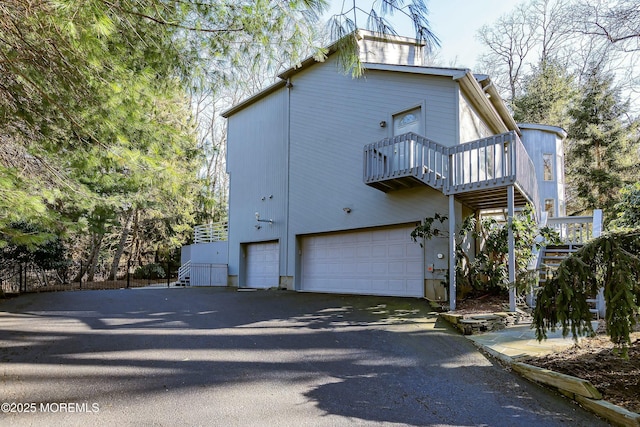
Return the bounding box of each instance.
[364,132,539,209]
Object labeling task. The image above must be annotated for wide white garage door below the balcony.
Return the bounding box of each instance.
[301,225,424,297]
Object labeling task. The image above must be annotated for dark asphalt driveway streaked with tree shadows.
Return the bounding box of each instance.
[0,288,604,426]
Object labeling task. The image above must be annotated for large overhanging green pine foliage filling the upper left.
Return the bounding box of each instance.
[0,0,323,247]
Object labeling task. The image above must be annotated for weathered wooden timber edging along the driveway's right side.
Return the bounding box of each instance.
[440,313,640,427]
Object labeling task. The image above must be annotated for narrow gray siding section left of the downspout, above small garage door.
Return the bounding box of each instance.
[227,88,288,285]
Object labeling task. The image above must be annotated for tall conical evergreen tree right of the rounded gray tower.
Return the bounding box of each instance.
[567,67,640,220]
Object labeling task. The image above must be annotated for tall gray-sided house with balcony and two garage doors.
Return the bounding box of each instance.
[183,32,580,307]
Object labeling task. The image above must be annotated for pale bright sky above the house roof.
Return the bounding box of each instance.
[326,0,520,68]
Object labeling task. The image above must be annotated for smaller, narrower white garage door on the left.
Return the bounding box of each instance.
[245,242,280,288]
